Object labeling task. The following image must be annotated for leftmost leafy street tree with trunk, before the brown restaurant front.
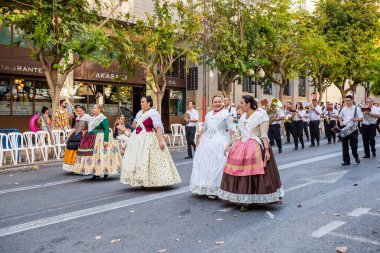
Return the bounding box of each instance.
[0,0,120,117]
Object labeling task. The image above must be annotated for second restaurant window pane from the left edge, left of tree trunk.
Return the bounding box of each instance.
[12,79,34,115]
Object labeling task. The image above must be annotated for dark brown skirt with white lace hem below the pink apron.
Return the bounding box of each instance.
[218,149,284,204]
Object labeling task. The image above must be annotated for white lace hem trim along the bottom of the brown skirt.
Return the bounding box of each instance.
[218,186,285,204]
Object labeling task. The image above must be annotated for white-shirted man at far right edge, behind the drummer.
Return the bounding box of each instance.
[362,98,380,158]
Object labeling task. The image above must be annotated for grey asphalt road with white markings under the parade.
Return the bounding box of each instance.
[0,137,380,253]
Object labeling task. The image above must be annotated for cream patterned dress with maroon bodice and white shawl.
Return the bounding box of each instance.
[120,109,181,187]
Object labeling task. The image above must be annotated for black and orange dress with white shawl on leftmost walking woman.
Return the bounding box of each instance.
[63,114,91,171]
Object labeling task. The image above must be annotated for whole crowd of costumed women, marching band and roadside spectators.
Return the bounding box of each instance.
[31,92,380,211]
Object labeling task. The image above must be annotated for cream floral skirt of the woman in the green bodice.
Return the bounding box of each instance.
[72,133,121,176]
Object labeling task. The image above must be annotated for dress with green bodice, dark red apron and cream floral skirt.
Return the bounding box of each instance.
[73,113,121,176]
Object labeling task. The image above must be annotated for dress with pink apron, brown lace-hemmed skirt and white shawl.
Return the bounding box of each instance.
[218,109,284,205]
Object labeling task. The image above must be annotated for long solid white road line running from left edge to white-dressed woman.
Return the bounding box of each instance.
[0,186,189,237]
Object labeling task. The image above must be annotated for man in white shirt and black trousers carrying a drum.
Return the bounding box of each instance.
[339,95,363,166]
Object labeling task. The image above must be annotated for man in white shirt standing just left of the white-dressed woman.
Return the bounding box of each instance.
[185,101,199,159]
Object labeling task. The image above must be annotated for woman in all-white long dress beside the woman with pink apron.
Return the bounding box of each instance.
[190,96,235,199]
